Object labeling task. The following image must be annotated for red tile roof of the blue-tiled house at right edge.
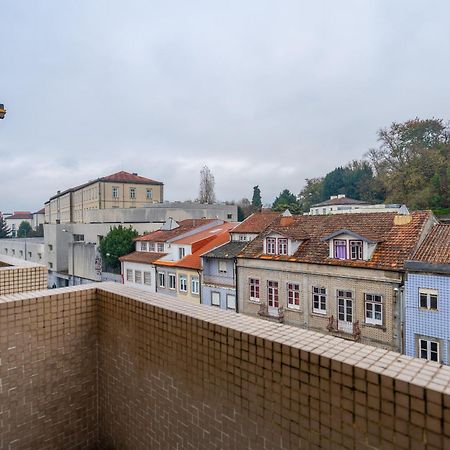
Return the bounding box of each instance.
[411,224,450,264]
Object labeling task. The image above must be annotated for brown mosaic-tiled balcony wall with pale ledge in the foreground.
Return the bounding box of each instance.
[0,284,450,450]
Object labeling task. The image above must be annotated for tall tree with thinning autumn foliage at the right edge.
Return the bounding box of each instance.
[368,118,450,208]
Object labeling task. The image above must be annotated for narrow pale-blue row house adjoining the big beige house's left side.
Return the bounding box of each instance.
[201,211,280,311]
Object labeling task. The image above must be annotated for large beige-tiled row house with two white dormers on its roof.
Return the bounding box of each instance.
[237,211,435,350]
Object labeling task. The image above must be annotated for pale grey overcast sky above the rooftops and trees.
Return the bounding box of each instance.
[0,0,450,212]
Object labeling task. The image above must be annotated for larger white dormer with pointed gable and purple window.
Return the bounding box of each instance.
[322,229,377,261]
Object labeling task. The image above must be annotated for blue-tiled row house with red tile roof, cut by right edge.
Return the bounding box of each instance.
[405,224,450,364]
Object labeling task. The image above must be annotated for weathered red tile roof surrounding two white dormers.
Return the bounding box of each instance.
[239,211,433,270]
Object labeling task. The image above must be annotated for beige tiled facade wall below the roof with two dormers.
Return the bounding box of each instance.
[237,258,402,351]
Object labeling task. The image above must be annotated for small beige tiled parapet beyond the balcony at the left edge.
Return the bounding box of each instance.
[0,256,47,295]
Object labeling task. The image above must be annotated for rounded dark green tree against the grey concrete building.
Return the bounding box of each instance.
[100,225,138,269]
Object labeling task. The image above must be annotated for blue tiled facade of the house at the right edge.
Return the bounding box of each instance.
[405,273,450,364]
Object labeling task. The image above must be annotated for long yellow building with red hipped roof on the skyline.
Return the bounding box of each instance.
[45,171,164,223]
